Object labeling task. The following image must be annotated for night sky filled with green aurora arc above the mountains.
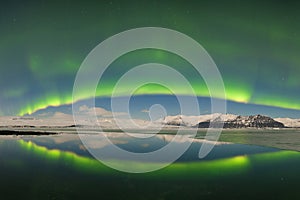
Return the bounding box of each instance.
[0,0,300,117]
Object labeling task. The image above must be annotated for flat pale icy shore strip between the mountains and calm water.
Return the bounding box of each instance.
[0,127,300,152]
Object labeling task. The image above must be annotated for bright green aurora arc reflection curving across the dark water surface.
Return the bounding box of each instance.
[18,140,300,177]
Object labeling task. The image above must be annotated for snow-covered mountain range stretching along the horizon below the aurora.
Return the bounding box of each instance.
[0,111,300,130]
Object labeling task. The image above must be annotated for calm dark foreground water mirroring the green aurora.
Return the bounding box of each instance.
[0,133,300,200]
